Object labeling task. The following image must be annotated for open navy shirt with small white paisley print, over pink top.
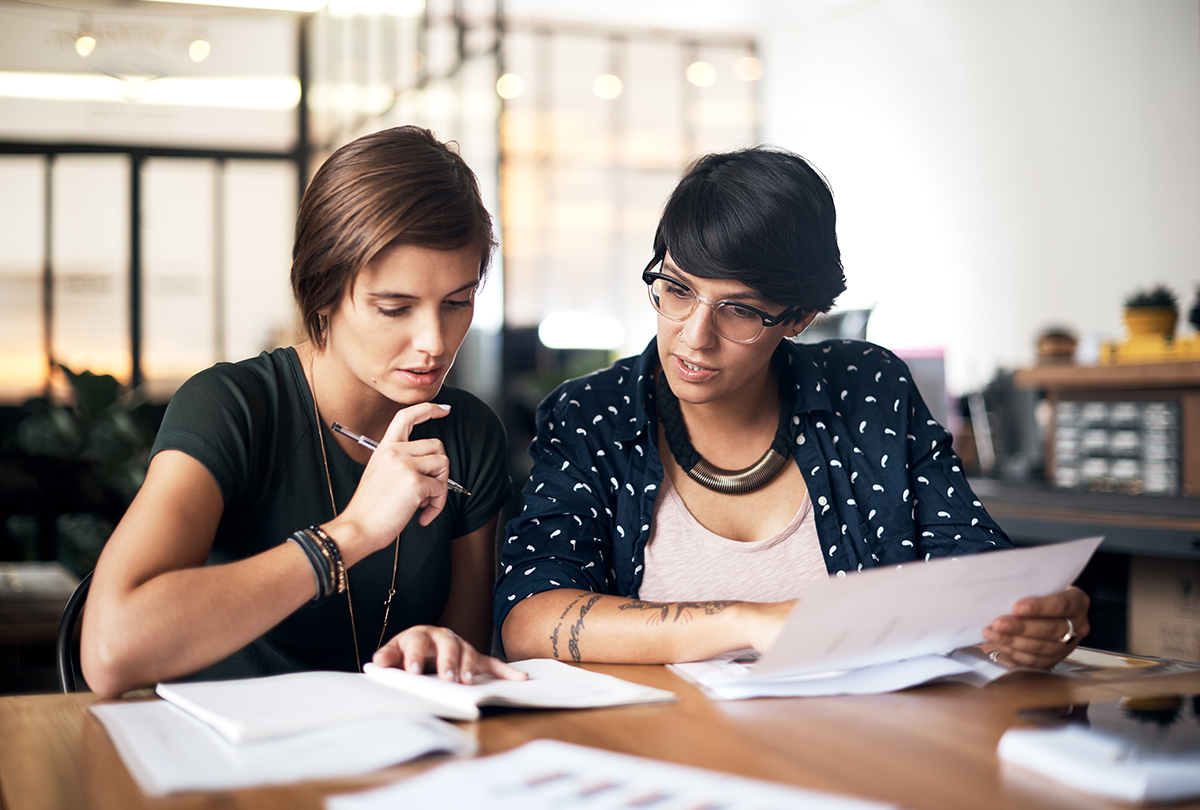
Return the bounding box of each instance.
[496,341,1012,628]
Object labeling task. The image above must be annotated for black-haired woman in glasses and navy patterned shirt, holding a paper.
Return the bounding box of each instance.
[494,148,1087,666]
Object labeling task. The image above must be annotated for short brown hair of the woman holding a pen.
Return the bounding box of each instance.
[292,126,496,347]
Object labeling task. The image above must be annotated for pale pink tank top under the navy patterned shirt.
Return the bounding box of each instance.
[637,476,829,602]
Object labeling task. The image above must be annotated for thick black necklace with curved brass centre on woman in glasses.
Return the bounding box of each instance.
[655,360,794,494]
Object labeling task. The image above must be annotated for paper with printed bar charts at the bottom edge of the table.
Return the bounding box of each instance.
[325,739,893,810]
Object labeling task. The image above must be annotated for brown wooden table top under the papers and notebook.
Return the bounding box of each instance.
[0,666,1200,810]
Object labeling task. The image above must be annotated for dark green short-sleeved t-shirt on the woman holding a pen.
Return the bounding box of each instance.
[152,348,512,679]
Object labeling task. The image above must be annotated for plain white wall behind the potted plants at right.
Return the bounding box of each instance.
[755,0,1200,392]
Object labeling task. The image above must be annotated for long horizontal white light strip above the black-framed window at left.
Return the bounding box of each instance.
[0,71,300,110]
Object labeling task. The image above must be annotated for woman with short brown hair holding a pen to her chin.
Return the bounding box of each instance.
[82,127,523,695]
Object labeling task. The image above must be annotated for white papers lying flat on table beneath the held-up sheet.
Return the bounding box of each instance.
[671,653,971,701]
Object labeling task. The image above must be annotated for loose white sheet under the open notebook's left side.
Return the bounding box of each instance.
[90,701,476,796]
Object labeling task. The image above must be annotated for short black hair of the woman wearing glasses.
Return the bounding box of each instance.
[647,146,846,319]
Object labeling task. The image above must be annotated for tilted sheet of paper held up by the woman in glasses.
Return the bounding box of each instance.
[750,538,1103,679]
